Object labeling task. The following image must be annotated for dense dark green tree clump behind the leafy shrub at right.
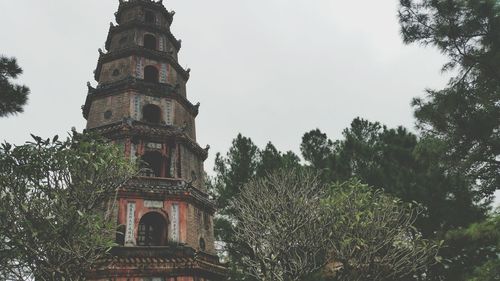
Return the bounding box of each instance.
[301,118,484,237]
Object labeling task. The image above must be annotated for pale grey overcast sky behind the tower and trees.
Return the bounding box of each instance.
[0,0,452,173]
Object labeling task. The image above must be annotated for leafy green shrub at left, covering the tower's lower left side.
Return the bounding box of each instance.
[0,132,135,280]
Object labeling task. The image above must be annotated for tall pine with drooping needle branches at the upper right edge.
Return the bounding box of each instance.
[399,0,500,198]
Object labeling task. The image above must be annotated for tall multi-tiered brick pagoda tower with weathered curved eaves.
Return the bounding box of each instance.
[83,0,225,281]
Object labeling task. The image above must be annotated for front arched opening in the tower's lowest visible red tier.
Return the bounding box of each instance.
[137,213,167,246]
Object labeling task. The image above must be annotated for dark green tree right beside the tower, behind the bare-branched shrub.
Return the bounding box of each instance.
[208,134,300,280]
